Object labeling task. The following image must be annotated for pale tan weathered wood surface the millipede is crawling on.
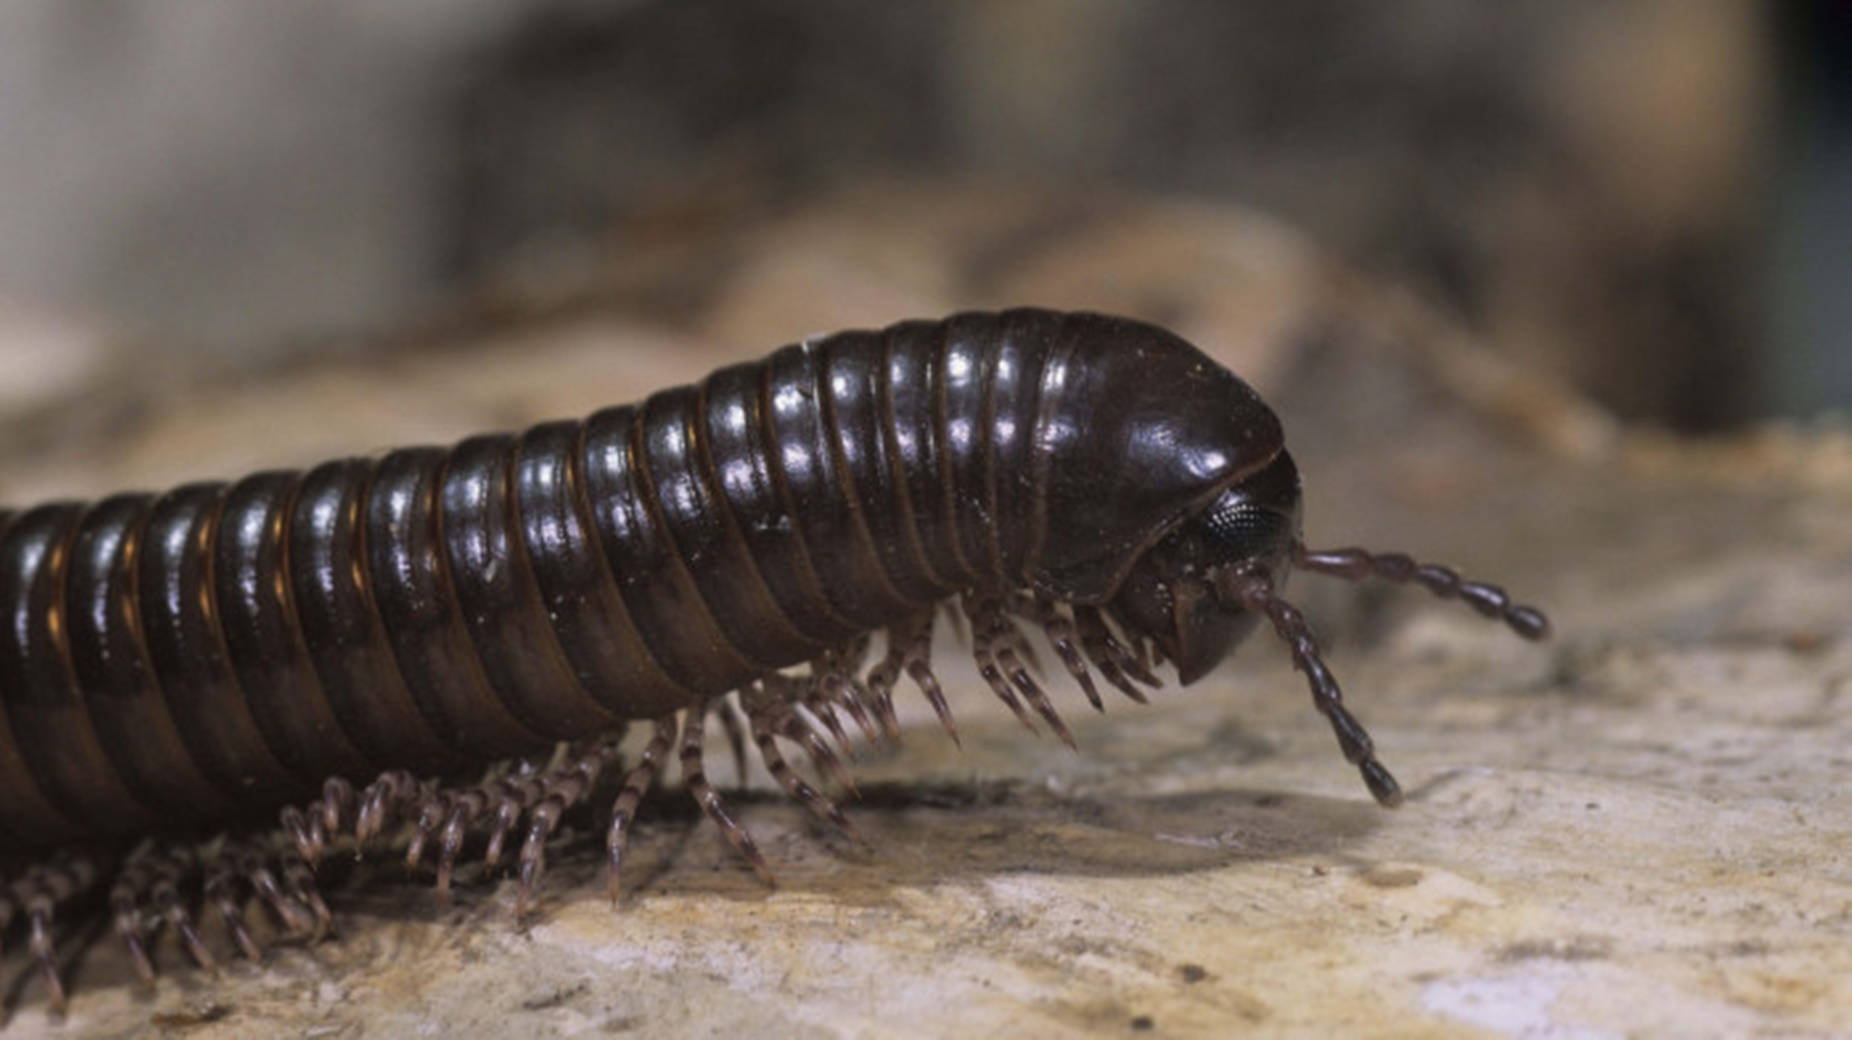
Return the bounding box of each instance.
[0,182,1852,1038]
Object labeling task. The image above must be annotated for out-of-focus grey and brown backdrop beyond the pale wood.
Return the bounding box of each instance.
[0,0,1852,457]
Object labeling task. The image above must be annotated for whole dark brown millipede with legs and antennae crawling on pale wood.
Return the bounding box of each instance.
[0,309,1548,1009]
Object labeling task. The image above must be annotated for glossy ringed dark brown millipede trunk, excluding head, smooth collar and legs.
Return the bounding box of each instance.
[0,311,1259,849]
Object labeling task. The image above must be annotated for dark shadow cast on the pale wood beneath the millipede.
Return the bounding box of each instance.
[0,779,1382,1014]
